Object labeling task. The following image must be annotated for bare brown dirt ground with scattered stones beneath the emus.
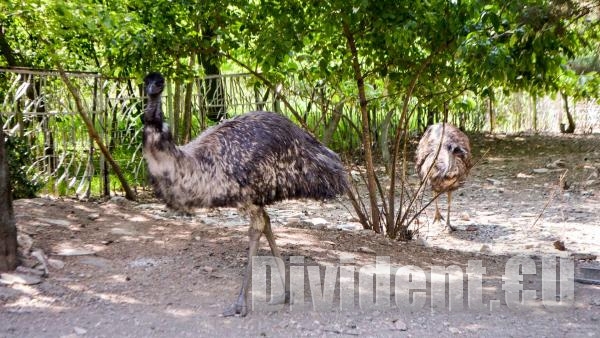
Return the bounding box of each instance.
[0,135,600,337]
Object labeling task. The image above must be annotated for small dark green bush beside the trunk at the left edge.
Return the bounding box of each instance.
[5,136,44,199]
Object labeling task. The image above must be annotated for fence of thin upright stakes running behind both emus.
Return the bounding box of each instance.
[0,68,600,198]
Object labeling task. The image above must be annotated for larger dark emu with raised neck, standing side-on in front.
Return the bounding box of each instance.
[143,73,348,316]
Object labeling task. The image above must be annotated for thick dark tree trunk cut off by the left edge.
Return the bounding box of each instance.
[0,125,19,271]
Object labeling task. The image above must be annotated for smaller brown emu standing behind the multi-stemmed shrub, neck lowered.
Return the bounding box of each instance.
[415,123,472,231]
